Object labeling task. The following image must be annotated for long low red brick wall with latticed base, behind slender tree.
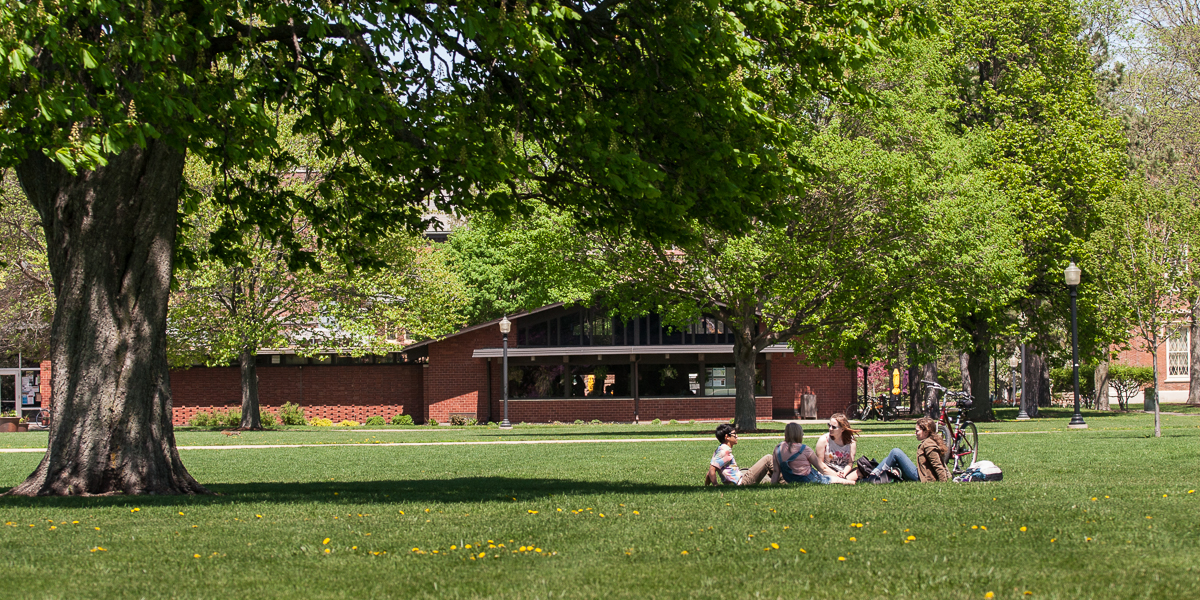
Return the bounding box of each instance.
[170,365,424,425]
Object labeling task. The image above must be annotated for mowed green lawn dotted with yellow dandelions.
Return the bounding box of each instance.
[0,414,1200,599]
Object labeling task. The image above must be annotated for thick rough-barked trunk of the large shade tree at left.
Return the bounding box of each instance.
[10,140,208,496]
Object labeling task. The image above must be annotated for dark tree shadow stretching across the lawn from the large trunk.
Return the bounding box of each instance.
[0,476,777,510]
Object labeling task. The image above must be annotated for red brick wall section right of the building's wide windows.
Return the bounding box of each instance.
[770,353,854,419]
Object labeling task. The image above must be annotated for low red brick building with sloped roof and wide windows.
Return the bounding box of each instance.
[49,305,856,425]
